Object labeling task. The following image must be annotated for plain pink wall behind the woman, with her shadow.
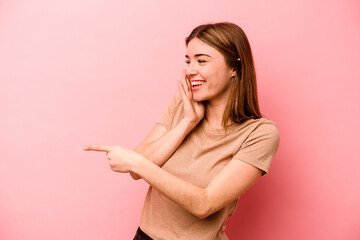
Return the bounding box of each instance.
[0,0,360,240]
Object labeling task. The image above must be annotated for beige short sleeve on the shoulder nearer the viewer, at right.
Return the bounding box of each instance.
[233,121,280,175]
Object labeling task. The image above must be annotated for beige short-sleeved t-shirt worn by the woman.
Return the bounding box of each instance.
[140,94,279,240]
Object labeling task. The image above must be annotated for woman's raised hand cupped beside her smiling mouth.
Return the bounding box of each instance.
[178,70,205,127]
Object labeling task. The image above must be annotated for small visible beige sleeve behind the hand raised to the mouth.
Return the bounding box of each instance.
[157,94,182,130]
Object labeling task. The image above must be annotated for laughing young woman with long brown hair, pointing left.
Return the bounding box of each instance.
[84,22,279,240]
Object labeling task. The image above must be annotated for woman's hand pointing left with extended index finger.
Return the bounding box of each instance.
[84,145,143,173]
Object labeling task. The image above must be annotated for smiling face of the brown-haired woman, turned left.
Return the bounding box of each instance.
[185,38,235,102]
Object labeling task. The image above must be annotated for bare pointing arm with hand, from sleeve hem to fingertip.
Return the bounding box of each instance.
[84,145,263,219]
